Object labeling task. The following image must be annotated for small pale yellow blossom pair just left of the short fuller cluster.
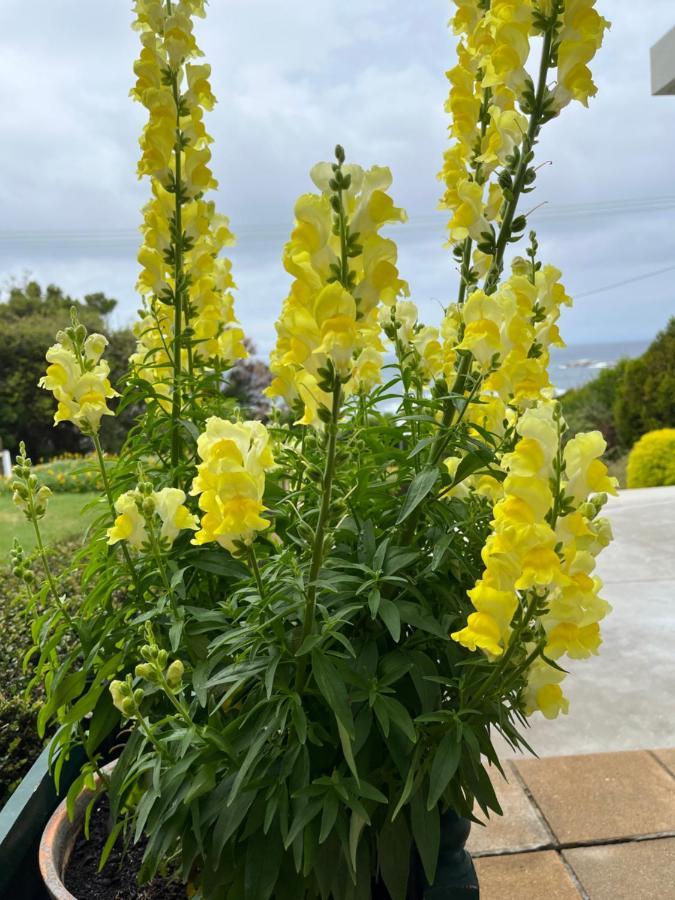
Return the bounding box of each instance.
[107,487,197,550]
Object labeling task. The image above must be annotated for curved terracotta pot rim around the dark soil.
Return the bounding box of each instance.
[38,762,115,900]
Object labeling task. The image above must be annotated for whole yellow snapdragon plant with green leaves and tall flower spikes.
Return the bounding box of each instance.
[9,0,614,900]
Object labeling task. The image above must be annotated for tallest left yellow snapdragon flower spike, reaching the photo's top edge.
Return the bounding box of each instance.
[131,0,247,398]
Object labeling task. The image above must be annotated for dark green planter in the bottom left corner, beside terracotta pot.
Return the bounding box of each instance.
[0,749,85,900]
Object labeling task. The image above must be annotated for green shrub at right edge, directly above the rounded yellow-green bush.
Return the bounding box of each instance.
[614,318,675,449]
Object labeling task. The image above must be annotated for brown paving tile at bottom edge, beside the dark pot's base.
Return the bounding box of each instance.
[475,850,584,900]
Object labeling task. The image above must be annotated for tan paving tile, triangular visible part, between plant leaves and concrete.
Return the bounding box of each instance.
[467,765,552,855]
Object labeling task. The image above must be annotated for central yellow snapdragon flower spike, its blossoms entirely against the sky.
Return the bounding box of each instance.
[267,163,409,427]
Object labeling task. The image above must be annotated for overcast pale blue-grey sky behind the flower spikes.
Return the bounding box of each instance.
[0,0,675,351]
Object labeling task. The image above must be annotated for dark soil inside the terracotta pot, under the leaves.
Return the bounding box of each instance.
[65,797,187,900]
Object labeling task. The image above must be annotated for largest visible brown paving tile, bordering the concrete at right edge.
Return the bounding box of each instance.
[514,751,675,844]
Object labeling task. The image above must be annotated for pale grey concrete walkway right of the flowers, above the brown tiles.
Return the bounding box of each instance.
[503,487,675,756]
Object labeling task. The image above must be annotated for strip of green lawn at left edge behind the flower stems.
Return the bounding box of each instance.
[0,493,97,565]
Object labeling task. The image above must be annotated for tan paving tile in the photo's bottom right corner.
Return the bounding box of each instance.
[564,838,675,900]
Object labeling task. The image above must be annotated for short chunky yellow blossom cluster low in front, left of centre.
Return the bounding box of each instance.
[190,416,274,553]
